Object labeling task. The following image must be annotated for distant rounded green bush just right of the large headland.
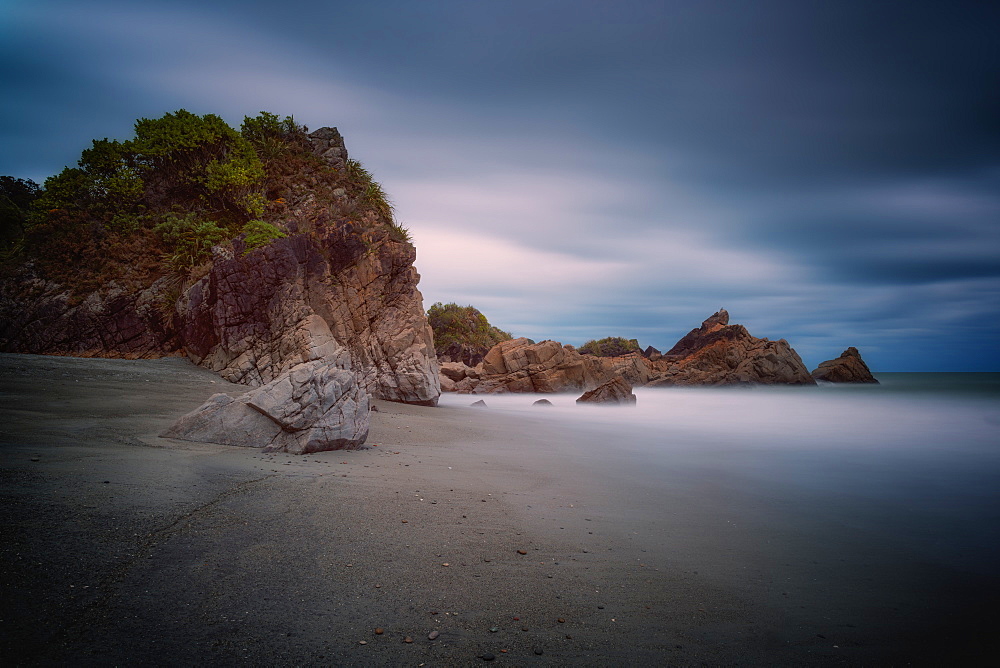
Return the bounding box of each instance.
[427,302,512,366]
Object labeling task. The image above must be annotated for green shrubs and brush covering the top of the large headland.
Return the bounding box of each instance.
[0,109,409,295]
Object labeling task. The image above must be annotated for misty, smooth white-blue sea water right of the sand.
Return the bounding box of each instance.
[441,373,1000,664]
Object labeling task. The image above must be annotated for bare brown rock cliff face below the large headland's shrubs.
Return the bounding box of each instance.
[0,128,440,405]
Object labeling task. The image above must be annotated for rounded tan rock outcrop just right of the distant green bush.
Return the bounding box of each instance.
[472,337,611,394]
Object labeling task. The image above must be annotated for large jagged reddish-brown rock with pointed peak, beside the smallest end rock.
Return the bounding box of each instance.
[648,309,816,387]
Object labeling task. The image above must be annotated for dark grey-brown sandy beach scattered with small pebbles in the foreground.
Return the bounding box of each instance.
[0,355,992,666]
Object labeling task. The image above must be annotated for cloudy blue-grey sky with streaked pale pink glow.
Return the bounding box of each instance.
[0,0,1000,371]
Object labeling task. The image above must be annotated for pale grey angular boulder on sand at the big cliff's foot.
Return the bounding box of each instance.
[161,355,370,454]
